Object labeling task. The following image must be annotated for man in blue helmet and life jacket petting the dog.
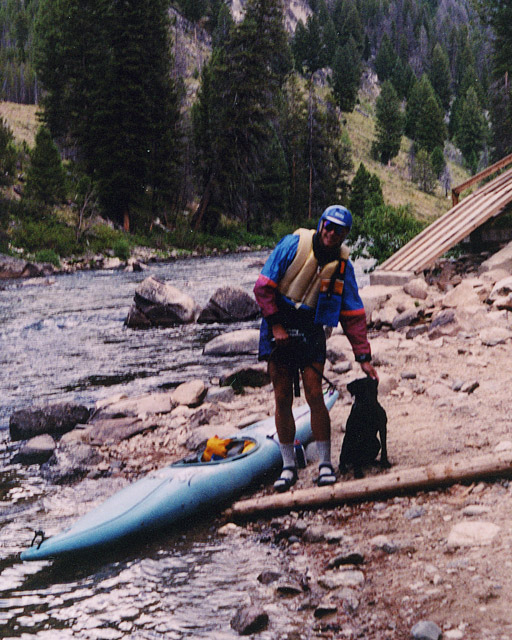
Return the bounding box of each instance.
[254,205,378,492]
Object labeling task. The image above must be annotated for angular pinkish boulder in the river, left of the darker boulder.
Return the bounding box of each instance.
[127,276,199,327]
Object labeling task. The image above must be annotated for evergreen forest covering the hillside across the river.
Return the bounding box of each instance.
[0,0,512,261]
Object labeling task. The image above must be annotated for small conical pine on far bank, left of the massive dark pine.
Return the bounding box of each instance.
[23,127,66,206]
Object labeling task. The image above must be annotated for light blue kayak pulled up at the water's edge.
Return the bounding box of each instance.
[21,384,338,560]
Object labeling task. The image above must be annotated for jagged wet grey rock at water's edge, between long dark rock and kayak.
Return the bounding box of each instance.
[41,444,102,484]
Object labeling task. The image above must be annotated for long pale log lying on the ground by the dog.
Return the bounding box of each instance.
[225,451,512,519]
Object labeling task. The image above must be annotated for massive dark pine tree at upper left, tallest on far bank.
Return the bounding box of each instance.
[37,0,179,228]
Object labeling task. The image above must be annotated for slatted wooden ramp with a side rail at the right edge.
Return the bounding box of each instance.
[370,155,512,284]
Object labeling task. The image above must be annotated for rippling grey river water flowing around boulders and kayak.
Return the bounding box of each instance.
[0,252,367,640]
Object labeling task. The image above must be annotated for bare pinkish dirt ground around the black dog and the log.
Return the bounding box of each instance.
[231,324,512,640]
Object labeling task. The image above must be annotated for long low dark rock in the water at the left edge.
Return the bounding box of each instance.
[9,403,91,440]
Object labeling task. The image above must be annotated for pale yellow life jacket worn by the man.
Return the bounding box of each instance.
[277,229,350,309]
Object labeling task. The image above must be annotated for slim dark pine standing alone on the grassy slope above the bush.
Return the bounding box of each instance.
[372,80,404,164]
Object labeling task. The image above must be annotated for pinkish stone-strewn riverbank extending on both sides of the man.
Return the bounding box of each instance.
[9,242,512,640]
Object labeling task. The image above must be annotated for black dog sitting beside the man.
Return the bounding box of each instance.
[340,378,391,478]
